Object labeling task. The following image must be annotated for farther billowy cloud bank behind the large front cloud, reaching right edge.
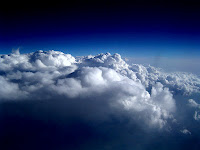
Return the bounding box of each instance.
[78,53,200,95]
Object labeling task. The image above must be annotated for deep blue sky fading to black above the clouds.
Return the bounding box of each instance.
[0,0,200,57]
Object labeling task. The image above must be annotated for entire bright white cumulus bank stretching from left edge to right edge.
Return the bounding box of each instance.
[0,51,200,128]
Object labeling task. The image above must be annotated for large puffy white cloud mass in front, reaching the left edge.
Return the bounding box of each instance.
[1,51,176,128]
